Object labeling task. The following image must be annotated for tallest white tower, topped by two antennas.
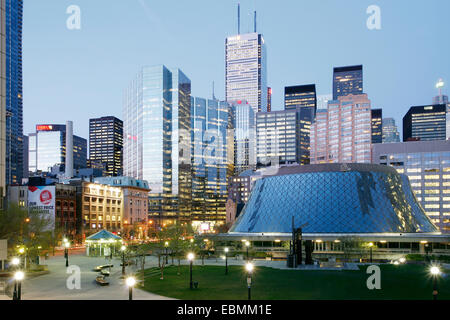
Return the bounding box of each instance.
[225,32,267,113]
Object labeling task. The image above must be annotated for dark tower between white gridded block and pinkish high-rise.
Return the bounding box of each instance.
[284,84,317,164]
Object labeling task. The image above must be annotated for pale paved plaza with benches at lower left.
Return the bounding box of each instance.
[18,255,172,300]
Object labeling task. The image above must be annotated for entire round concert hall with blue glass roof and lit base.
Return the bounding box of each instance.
[214,164,450,259]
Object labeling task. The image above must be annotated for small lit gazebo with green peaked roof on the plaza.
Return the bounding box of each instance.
[86,230,122,257]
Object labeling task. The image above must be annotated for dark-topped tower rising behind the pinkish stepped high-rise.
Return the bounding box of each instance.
[333,65,363,100]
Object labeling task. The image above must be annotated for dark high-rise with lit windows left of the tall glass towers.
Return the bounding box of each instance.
[89,117,123,176]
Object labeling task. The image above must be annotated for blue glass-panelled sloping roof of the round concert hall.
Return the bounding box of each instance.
[229,164,439,234]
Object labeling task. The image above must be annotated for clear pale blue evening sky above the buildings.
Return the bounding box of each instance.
[24,1,450,138]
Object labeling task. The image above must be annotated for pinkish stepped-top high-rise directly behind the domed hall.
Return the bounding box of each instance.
[311,94,372,164]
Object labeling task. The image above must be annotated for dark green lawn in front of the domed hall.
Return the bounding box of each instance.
[140,265,450,300]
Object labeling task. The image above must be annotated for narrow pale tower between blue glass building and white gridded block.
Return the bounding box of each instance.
[230,100,256,175]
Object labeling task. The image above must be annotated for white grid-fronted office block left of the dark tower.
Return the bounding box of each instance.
[256,108,298,167]
